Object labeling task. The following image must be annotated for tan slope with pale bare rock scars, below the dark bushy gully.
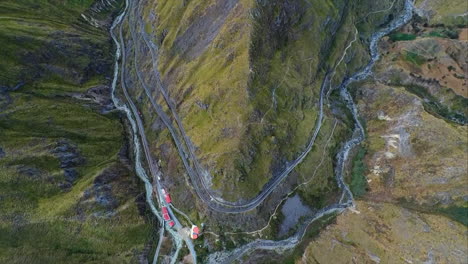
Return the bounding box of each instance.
[359,80,468,205]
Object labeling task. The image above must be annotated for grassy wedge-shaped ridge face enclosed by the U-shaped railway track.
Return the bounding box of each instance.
[151,0,358,200]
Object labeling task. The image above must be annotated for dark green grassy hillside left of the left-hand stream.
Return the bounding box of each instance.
[0,0,152,263]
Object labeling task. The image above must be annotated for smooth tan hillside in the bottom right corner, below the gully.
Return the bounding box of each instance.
[296,202,466,263]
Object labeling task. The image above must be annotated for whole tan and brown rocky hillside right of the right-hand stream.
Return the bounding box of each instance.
[296,1,468,263]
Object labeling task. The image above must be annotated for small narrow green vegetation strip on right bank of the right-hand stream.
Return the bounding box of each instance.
[349,147,367,198]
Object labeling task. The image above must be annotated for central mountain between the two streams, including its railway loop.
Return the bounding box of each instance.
[110,1,432,260]
